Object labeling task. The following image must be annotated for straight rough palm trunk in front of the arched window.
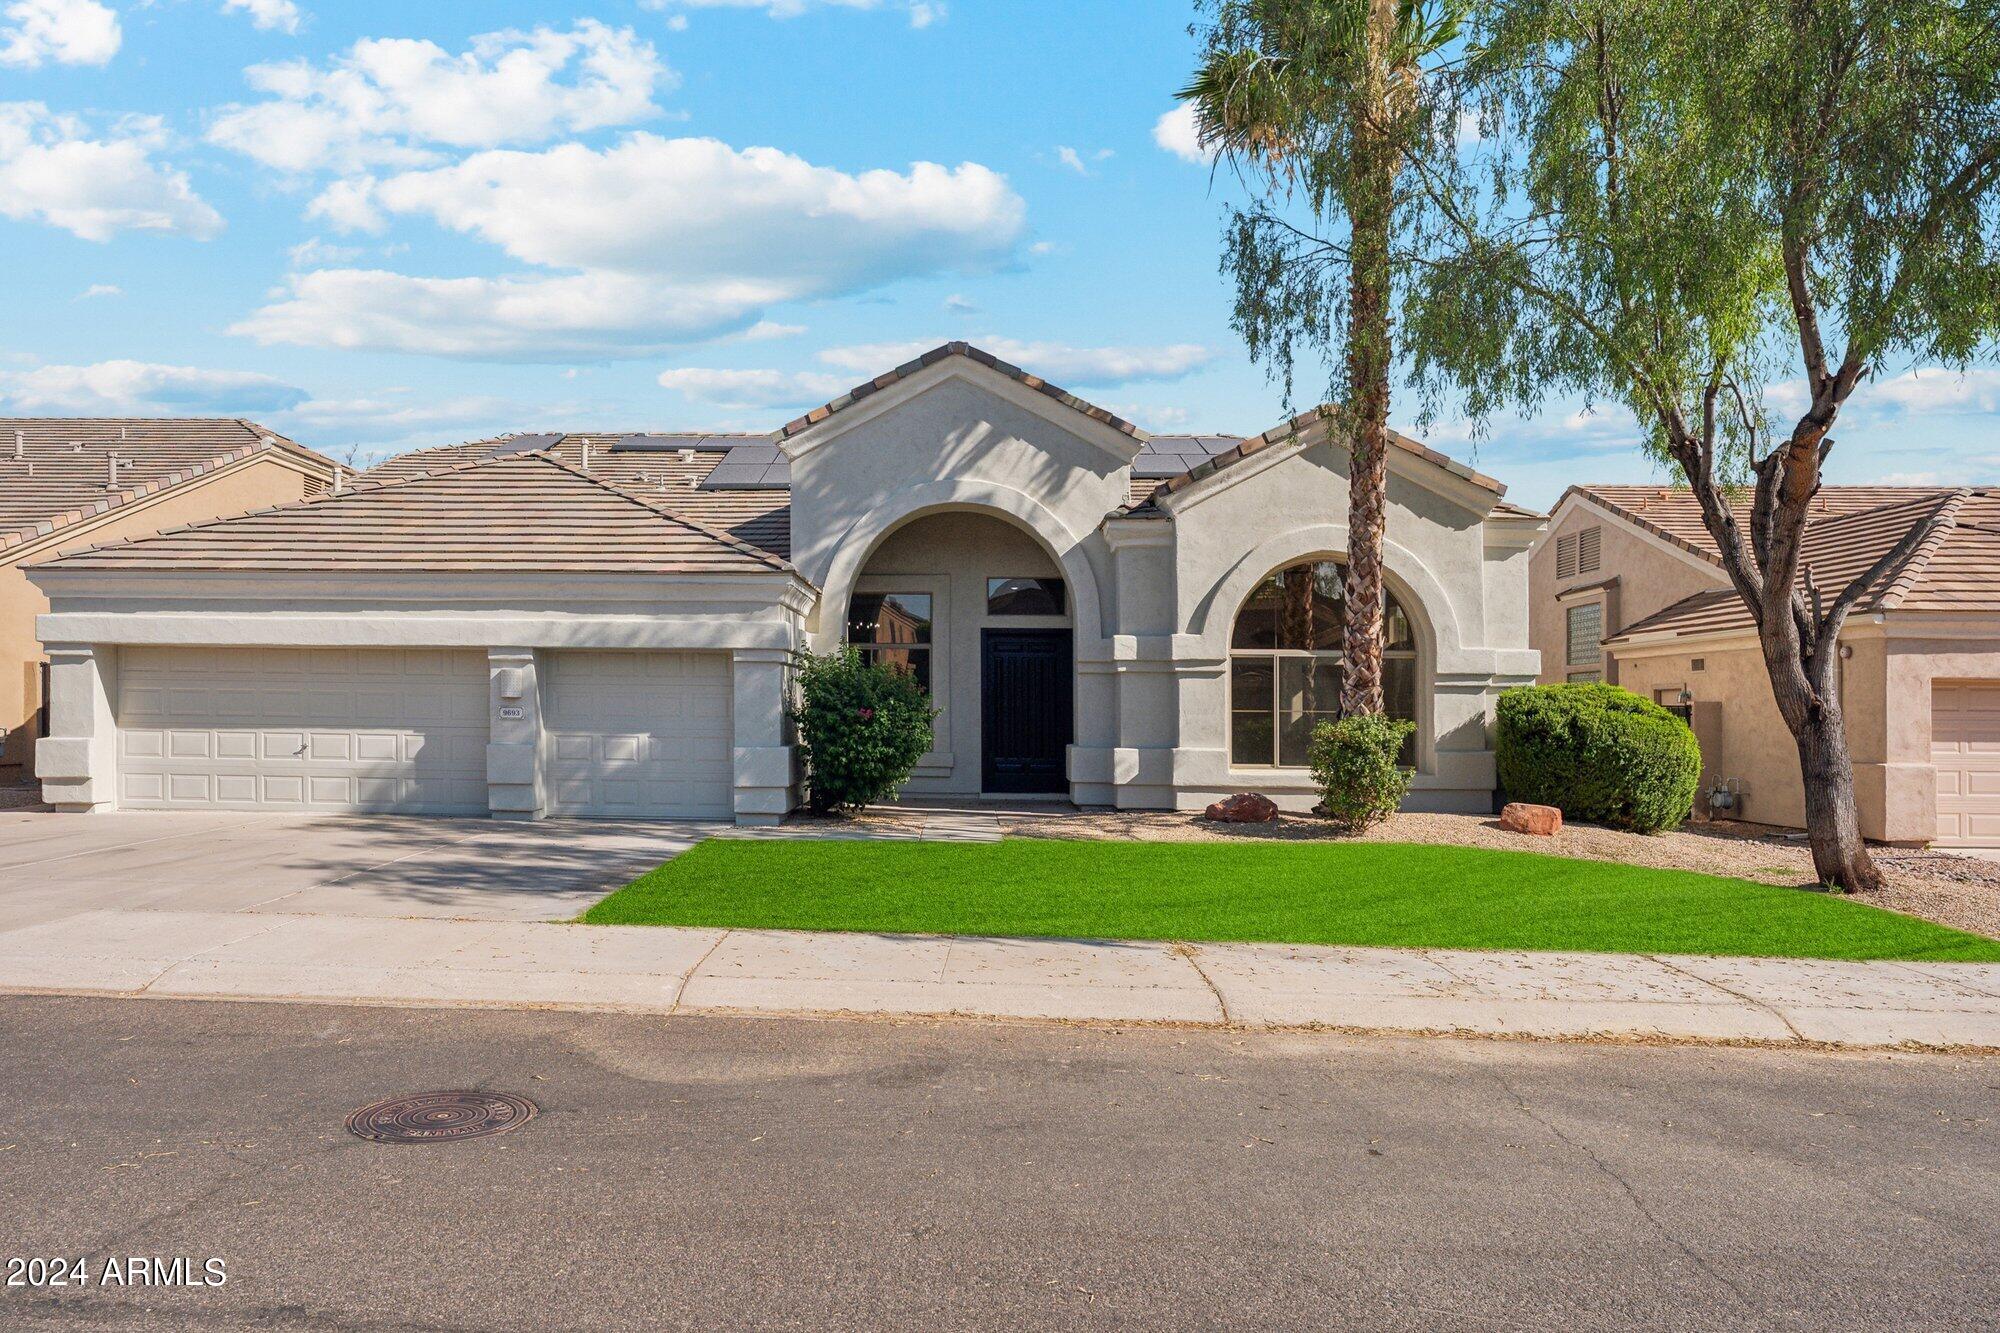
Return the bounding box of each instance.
[1340,0,1396,717]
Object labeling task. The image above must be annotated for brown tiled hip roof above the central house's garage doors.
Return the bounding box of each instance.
[33,452,788,574]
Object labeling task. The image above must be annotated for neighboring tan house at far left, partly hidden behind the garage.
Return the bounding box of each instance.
[0,416,334,783]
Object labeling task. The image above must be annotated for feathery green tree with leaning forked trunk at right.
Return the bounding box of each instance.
[1412,0,2000,891]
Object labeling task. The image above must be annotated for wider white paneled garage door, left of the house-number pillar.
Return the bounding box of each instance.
[118,648,488,815]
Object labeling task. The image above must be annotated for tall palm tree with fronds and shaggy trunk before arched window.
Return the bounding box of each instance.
[1180,0,1462,715]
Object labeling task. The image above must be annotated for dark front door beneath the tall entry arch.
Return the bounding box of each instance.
[980,630,1074,795]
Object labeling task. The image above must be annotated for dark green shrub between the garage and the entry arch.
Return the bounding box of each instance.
[790,648,936,815]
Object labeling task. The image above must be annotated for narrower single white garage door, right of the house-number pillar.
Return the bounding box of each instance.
[544,652,734,819]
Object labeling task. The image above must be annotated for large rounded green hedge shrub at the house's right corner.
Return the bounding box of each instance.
[1496,685,1702,833]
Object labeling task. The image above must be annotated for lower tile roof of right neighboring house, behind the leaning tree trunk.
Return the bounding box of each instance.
[1606,488,2000,646]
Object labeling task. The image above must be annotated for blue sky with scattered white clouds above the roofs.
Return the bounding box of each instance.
[0,0,2000,504]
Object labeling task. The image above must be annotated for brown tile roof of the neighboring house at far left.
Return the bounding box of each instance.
[0,416,334,552]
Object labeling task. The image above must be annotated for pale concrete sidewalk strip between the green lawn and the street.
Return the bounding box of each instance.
[0,907,2000,1051]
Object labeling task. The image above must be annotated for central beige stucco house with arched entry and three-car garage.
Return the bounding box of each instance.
[19,344,1542,823]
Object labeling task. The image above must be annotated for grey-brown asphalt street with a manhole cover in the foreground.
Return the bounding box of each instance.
[0,997,2000,1329]
